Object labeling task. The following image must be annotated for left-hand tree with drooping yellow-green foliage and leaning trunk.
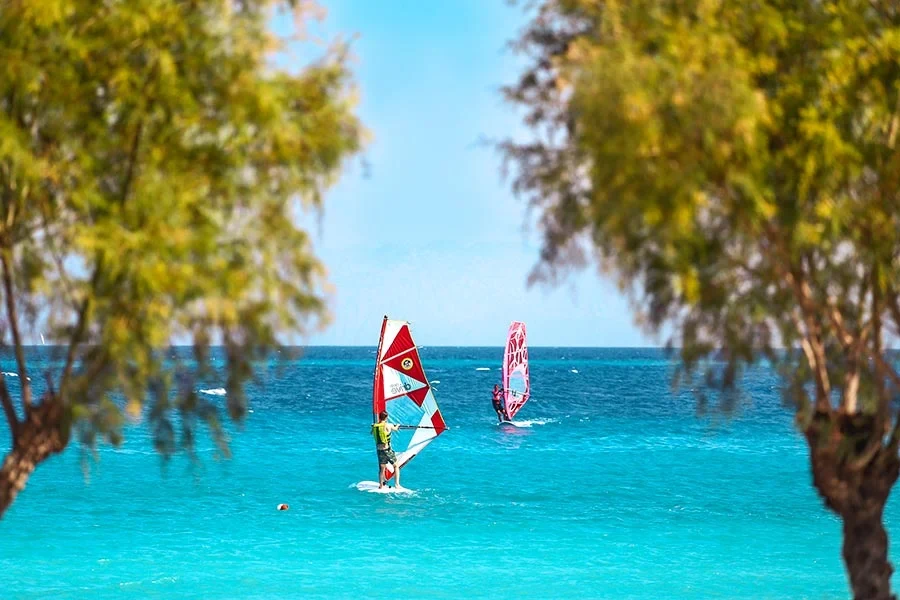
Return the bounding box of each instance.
[0,0,362,516]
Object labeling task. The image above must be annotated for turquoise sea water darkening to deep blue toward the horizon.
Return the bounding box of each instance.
[0,347,884,600]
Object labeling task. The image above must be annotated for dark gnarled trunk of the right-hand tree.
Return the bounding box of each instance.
[805,412,900,600]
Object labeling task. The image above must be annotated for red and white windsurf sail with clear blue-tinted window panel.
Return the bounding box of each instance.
[372,317,447,478]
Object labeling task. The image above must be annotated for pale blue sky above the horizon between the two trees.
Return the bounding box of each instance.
[275,0,656,346]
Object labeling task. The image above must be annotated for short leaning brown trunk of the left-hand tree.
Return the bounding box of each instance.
[0,398,68,518]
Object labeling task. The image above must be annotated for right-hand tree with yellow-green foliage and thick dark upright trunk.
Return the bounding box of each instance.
[502,0,900,599]
